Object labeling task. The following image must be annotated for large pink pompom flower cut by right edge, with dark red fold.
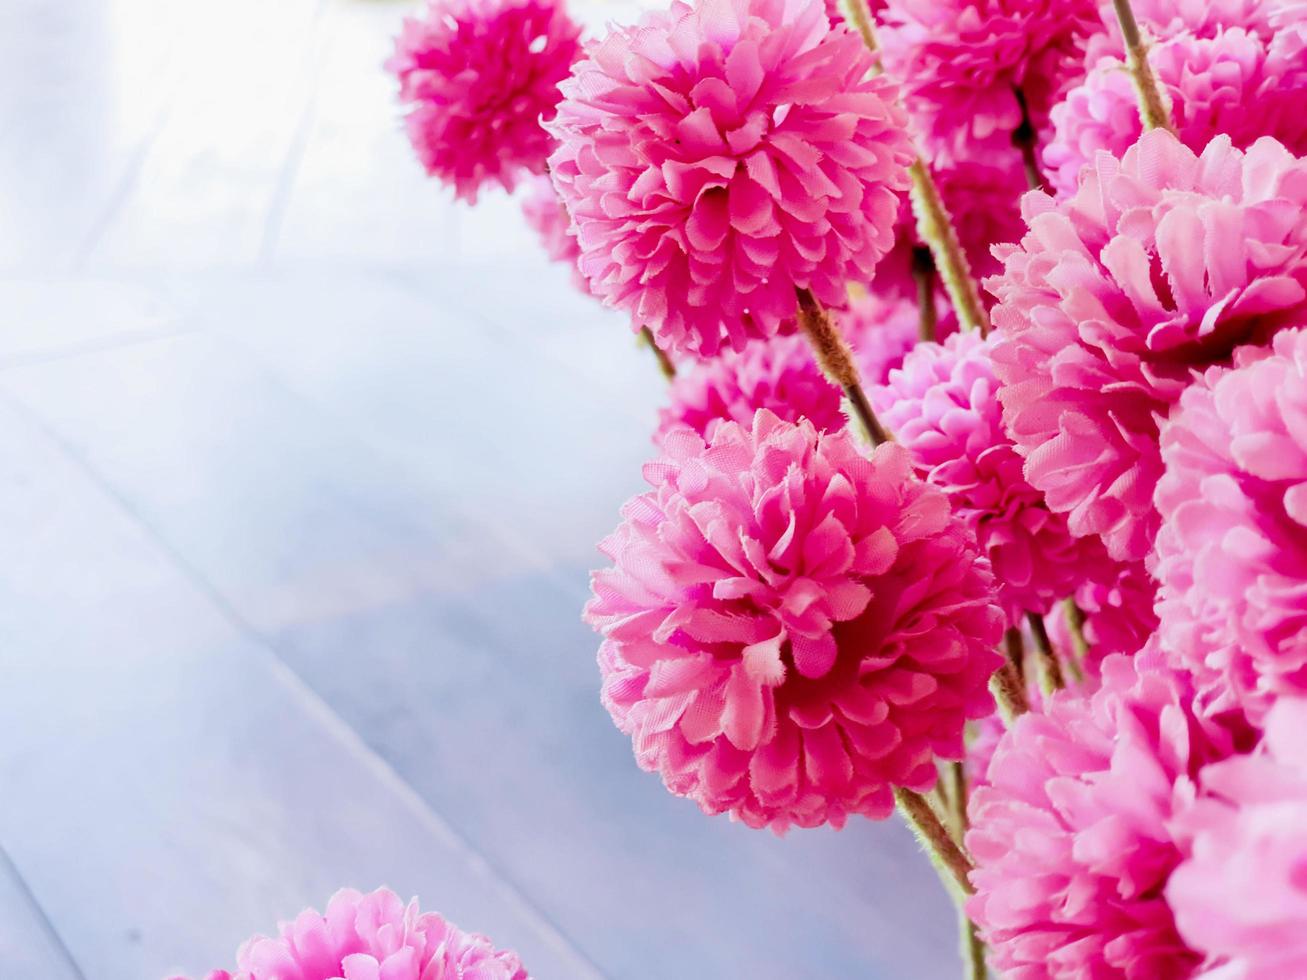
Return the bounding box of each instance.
[985,131,1307,561]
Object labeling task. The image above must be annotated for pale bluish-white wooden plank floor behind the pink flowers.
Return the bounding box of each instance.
[0,0,957,980]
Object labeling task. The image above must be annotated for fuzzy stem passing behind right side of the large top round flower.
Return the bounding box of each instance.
[840,0,989,337]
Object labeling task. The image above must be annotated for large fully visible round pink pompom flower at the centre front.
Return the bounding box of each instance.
[586,412,1002,831]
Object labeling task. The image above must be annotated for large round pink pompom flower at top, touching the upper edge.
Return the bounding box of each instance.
[550,0,911,357]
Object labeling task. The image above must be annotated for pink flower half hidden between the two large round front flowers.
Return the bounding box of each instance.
[654,335,848,443]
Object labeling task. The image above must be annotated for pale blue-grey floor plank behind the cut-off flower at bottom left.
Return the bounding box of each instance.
[0,399,596,980]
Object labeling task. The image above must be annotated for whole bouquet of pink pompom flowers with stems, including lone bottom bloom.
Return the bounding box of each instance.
[181,0,1307,980]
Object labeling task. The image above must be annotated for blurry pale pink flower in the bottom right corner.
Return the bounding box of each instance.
[1166,698,1307,980]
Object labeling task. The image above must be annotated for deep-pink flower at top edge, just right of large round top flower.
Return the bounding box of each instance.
[880,0,1100,167]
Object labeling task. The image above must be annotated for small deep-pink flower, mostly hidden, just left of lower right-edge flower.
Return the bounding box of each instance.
[1046,559,1157,677]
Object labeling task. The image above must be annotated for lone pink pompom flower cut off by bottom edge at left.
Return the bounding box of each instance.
[180,889,529,980]
